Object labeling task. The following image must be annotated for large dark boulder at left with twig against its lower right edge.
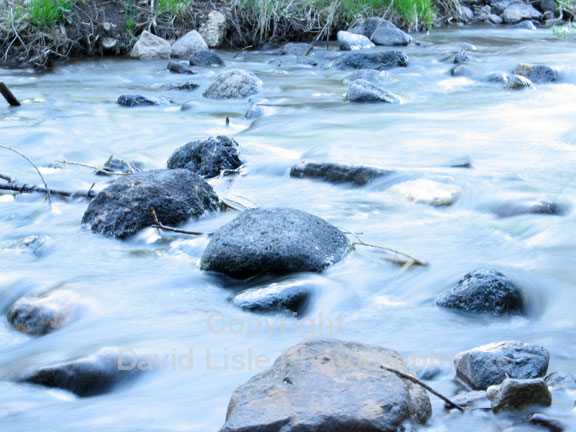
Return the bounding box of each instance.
[82,169,219,238]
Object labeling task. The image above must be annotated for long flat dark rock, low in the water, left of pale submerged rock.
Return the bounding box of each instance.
[290,162,394,186]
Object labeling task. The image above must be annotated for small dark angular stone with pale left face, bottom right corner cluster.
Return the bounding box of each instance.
[486,378,552,413]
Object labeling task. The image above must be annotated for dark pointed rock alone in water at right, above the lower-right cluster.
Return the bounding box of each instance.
[436,269,524,315]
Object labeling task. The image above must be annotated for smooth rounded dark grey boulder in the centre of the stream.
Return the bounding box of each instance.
[200,208,348,279]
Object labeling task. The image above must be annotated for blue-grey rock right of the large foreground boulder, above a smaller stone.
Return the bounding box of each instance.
[454,341,550,390]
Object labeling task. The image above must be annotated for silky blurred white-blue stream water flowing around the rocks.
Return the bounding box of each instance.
[0,28,576,432]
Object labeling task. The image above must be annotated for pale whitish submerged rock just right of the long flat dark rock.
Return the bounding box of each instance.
[388,179,462,207]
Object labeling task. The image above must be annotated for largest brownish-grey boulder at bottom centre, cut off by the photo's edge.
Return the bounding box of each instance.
[220,339,432,432]
